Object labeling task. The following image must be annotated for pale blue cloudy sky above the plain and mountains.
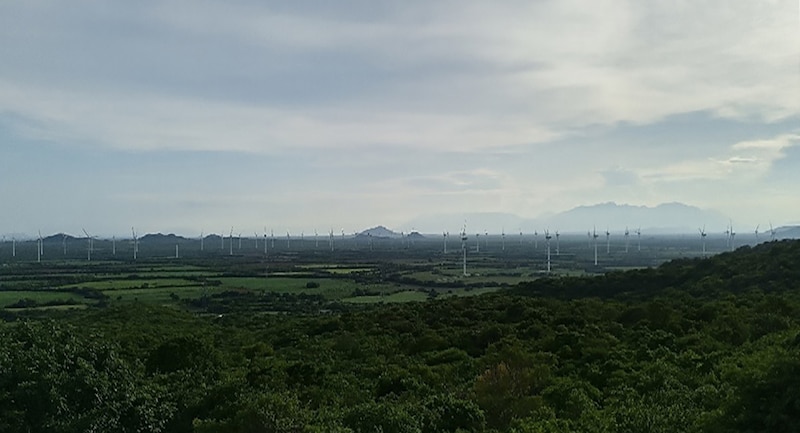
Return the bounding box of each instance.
[0,0,800,236]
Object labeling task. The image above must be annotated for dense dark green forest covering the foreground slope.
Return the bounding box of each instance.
[0,241,800,433]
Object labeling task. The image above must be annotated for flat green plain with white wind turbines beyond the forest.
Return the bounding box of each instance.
[0,219,792,314]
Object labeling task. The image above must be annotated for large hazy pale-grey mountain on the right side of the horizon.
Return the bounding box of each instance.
[541,202,729,233]
